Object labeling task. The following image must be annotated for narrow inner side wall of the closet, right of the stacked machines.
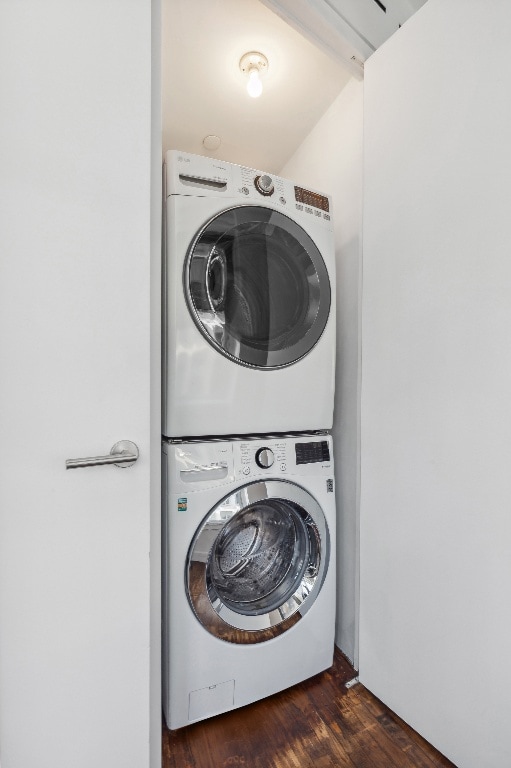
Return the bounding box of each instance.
[280,79,363,664]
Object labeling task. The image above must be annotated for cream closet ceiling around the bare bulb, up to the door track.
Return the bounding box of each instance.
[162,0,351,173]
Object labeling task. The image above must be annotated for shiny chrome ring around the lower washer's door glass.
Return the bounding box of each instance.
[186,480,330,642]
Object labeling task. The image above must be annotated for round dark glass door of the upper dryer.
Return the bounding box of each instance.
[184,205,330,368]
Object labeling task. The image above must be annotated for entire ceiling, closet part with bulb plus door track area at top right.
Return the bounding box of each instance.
[162,0,426,173]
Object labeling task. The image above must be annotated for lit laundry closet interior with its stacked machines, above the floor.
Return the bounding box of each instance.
[162,0,362,727]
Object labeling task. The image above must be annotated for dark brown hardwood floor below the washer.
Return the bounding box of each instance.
[163,651,455,768]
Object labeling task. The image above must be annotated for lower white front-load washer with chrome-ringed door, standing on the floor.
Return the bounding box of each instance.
[163,435,335,729]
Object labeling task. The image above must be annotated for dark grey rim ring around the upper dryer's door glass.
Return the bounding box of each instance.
[183,204,331,370]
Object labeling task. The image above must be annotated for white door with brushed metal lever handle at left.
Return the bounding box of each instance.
[0,0,160,768]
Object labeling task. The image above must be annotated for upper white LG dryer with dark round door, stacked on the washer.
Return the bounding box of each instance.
[162,151,335,437]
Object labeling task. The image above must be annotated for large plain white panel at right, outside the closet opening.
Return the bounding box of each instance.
[360,0,511,768]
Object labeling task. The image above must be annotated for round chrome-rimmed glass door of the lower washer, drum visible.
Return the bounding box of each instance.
[186,480,330,643]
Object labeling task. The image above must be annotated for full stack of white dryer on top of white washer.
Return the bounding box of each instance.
[162,151,336,729]
